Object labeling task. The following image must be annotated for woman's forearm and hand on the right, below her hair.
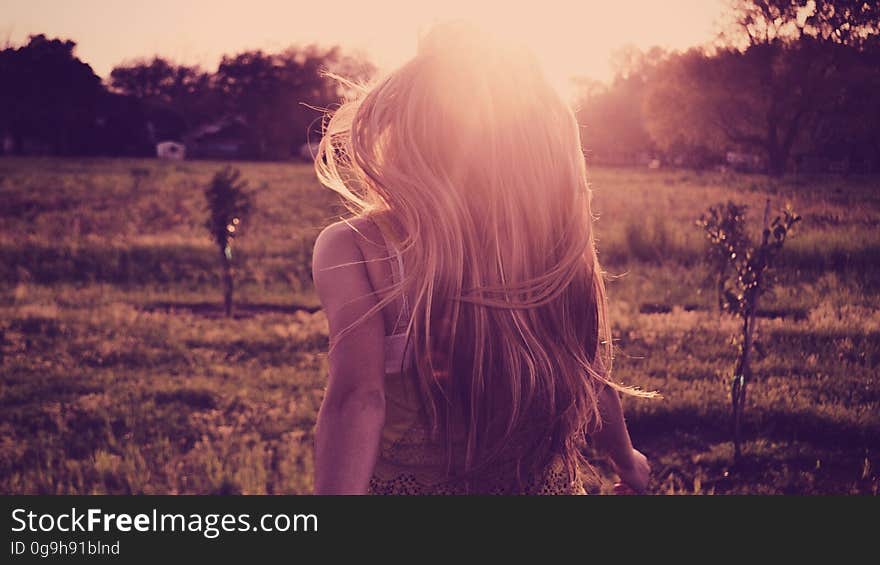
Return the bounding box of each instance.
[591,385,651,492]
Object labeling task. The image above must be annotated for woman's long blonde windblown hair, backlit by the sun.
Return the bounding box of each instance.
[315,23,648,490]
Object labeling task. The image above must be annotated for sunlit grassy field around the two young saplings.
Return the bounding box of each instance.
[0,158,880,494]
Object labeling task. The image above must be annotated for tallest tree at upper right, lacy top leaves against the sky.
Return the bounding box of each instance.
[646,0,880,175]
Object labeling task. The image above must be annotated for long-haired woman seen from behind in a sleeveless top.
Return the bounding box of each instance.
[313,24,649,494]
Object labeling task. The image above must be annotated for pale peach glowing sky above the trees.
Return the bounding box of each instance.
[0,0,724,94]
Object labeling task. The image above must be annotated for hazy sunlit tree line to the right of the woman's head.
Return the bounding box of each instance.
[578,0,880,175]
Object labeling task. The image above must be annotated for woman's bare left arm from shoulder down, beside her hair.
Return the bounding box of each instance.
[312,223,385,494]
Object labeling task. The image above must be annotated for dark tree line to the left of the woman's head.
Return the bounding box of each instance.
[0,35,375,159]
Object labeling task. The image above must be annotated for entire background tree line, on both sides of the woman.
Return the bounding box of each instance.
[0,0,880,175]
